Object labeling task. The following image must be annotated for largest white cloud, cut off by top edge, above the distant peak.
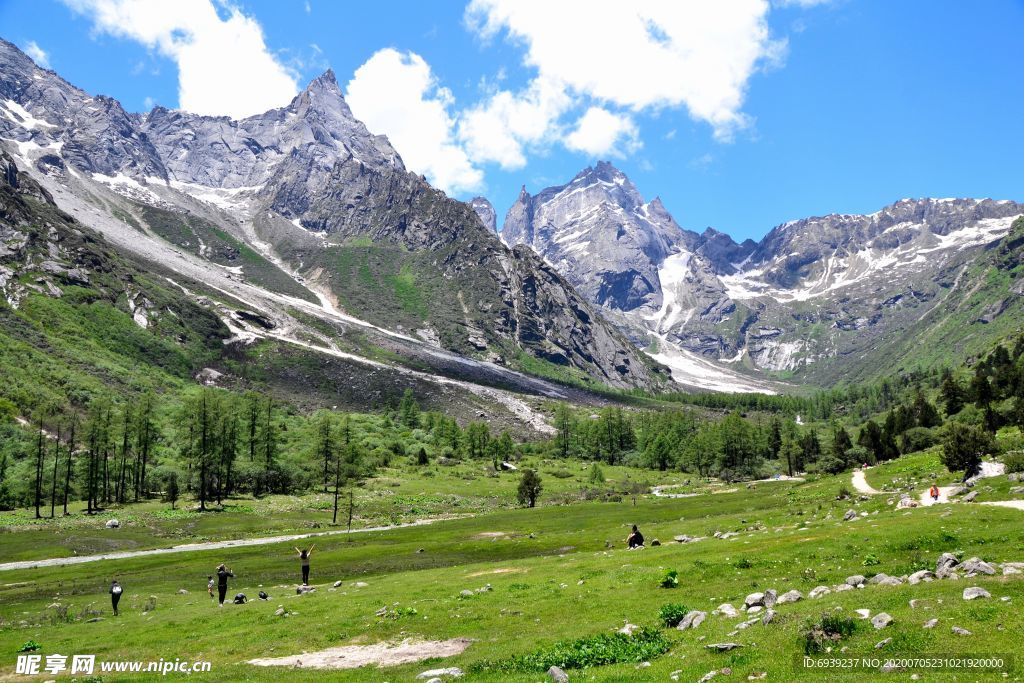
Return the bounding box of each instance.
[466,0,784,139]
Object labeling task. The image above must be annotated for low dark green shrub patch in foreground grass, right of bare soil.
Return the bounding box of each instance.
[470,629,672,673]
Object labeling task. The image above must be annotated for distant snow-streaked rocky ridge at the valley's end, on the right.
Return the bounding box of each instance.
[502,162,1024,389]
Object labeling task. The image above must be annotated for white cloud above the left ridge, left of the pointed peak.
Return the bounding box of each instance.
[63,0,298,118]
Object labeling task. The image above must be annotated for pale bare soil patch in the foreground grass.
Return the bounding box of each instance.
[249,638,473,669]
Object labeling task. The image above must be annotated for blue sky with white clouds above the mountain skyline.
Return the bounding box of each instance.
[0,0,1024,240]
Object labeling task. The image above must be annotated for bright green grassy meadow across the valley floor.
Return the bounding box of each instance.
[0,455,1024,682]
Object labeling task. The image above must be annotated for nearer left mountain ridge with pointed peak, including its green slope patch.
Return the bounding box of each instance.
[0,42,665,388]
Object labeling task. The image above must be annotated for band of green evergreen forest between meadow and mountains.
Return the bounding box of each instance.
[0,341,1024,516]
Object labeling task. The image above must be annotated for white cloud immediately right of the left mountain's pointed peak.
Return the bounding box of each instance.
[345,48,483,193]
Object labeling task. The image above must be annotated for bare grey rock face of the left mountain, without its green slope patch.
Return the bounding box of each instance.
[0,41,663,387]
